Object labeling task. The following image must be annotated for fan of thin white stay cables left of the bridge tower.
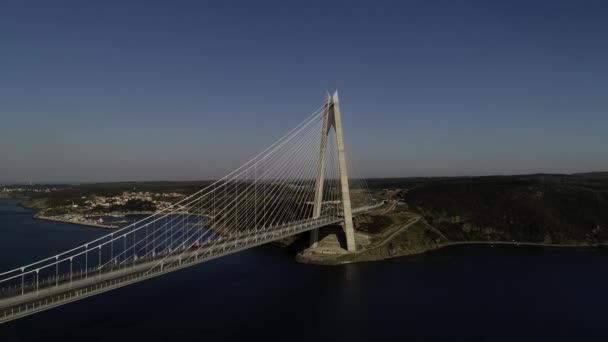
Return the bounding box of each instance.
[0,99,371,297]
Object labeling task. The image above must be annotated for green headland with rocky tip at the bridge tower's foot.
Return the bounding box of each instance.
[297,173,608,265]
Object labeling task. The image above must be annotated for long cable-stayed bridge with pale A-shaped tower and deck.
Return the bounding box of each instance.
[0,92,381,323]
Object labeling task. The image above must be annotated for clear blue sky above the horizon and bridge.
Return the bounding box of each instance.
[0,0,608,182]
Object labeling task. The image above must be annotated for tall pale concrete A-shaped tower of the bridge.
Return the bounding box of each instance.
[310,90,357,252]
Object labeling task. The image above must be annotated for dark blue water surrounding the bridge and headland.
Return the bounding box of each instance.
[0,200,608,342]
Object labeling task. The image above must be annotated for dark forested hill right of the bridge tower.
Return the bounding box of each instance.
[372,173,608,244]
